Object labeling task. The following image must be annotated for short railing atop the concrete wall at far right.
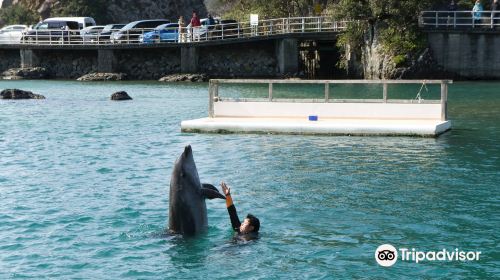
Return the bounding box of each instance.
[419,11,500,29]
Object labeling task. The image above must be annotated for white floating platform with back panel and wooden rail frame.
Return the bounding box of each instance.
[181,80,451,137]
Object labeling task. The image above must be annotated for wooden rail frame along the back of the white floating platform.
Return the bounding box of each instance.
[208,79,453,121]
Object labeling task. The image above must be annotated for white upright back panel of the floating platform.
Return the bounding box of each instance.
[214,102,442,120]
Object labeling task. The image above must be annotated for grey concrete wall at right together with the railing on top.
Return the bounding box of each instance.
[419,11,500,79]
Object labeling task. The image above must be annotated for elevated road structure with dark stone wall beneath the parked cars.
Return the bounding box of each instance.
[0,18,343,79]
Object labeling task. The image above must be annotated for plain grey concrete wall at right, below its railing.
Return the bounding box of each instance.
[428,31,500,79]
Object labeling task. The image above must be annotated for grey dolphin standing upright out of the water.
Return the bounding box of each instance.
[168,145,226,236]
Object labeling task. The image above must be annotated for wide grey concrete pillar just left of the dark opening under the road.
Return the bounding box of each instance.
[276,38,299,75]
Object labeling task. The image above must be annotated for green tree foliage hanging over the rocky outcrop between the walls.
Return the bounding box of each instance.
[331,0,448,69]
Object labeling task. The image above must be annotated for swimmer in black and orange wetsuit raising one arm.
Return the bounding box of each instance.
[220,182,260,236]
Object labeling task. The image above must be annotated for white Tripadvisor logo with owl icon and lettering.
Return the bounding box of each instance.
[375,244,481,267]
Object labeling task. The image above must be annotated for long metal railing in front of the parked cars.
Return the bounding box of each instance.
[0,17,348,45]
